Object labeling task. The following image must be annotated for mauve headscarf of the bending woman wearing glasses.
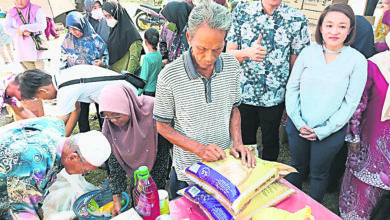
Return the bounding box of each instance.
[99,84,158,176]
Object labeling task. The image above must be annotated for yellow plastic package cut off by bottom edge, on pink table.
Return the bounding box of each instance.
[252,206,314,220]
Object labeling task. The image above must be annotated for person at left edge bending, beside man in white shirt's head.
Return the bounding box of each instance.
[0,74,35,119]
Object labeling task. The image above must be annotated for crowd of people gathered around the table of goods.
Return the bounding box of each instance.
[0,0,390,219]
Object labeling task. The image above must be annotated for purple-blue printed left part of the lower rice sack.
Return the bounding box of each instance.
[184,184,234,220]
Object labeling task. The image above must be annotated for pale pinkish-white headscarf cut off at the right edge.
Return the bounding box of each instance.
[369,33,390,121]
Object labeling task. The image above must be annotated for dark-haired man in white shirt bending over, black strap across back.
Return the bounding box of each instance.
[20,65,138,136]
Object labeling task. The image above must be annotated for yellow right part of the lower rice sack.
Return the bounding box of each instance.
[236,181,296,220]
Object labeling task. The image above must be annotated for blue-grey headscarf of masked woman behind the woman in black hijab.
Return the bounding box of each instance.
[84,0,110,42]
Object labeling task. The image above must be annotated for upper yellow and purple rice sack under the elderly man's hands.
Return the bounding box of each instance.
[185,149,296,215]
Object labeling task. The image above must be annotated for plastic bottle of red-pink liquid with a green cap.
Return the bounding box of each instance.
[133,166,160,220]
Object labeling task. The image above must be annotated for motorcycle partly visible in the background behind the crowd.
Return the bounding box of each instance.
[134,4,165,31]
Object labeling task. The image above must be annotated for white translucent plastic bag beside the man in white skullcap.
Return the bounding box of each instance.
[42,169,99,220]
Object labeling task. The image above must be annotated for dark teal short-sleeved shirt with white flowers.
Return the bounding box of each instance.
[228,1,310,107]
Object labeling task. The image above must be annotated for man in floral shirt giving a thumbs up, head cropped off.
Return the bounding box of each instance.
[227,0,310,161]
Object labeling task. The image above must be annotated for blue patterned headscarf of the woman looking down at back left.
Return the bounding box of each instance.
[61,11,107,67]
